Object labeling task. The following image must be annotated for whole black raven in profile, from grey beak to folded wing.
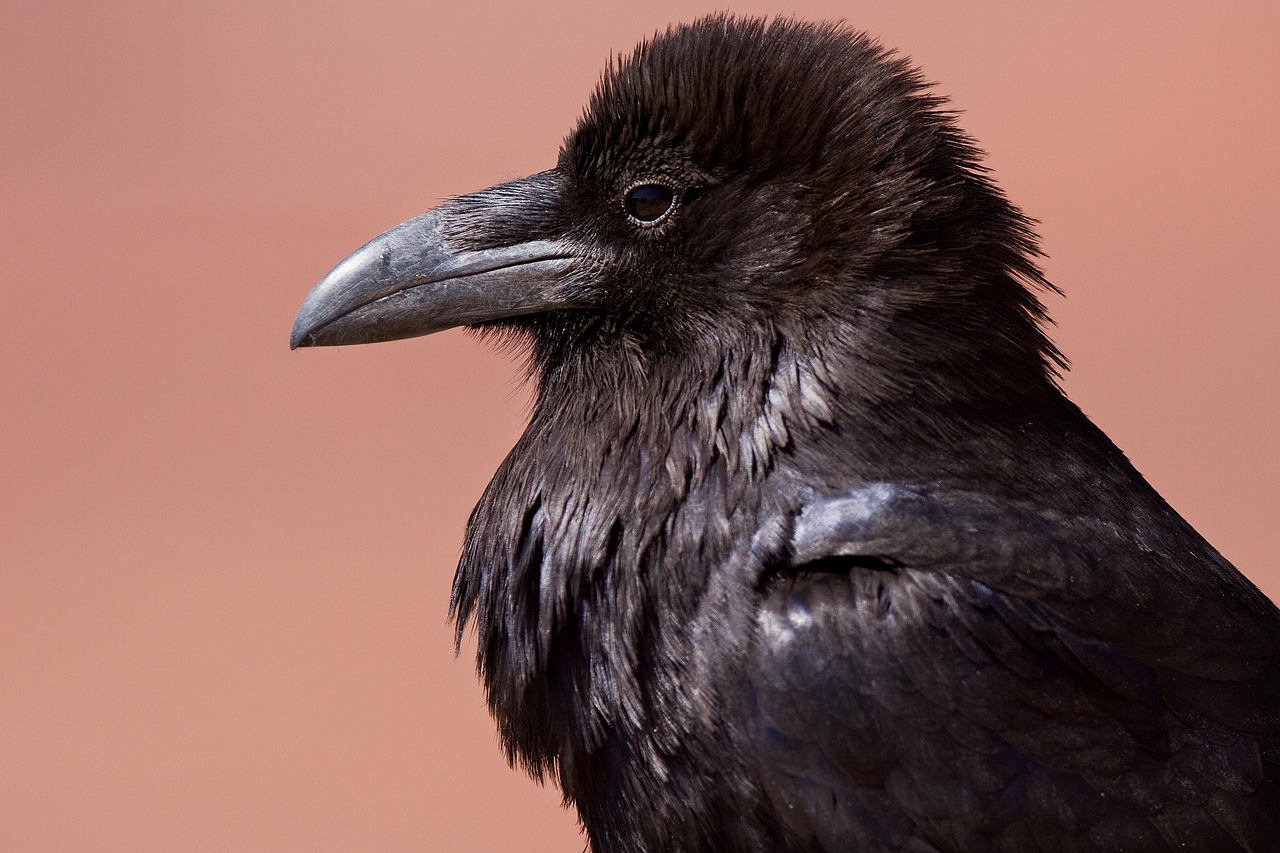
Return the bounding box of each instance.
[291,17,1280,853]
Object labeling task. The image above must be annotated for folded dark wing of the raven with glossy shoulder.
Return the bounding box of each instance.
[744,484,1280,853]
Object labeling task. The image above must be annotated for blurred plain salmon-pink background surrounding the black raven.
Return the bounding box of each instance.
[0,0,1280,852]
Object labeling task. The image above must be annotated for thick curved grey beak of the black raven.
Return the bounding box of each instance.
[289,172,590,350]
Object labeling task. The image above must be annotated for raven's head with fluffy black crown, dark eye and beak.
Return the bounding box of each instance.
[291,15,1059,397]
